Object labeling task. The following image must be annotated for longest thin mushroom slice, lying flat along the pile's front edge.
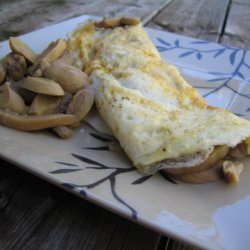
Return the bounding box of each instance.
[0,110,78,131]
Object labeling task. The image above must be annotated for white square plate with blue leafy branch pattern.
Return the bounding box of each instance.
[0,16,250,249]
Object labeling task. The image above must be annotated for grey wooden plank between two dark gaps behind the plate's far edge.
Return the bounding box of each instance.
[149,0,229,42]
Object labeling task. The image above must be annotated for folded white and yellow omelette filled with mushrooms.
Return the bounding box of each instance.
[68,17,250,182]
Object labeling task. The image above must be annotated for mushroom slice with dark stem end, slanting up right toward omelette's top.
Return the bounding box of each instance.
[28,39,66,77]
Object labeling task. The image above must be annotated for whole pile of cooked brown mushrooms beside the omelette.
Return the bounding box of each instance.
[0,37,95,138]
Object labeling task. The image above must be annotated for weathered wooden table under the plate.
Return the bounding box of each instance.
[0,0,250,250]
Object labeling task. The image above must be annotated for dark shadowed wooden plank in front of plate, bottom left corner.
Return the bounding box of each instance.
[0,161,159,250]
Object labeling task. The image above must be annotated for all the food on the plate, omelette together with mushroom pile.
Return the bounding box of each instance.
[0,17,250,184]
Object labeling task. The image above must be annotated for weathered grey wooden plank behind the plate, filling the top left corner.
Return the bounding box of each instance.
[0,0,170,41]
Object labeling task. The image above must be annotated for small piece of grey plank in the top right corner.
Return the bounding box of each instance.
[221,1,250,49]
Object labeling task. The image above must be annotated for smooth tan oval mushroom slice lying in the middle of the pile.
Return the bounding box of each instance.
[20,76,64,96]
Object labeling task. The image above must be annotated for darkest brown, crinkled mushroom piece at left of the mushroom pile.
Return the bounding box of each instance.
[4,53,27,81]
